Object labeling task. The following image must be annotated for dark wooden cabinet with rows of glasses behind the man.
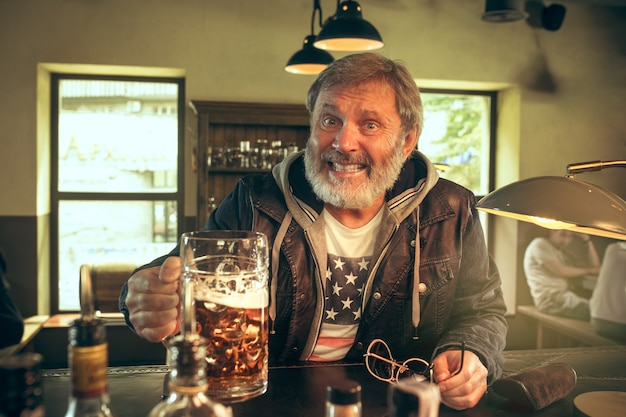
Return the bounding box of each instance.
[191,101,309,228]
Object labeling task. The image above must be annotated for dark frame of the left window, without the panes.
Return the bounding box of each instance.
[50,72,186,314]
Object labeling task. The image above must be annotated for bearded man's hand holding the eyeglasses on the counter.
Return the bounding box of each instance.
[433,350,488,410]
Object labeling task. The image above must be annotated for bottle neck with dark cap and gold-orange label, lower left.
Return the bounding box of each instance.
[65,315,113,417]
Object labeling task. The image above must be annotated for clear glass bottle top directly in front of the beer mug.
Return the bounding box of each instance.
[148,335,232,417]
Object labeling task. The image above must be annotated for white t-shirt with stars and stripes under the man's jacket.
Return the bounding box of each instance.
[309,210,382,361]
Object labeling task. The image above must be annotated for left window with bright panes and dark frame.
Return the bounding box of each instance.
[51,74,184,313]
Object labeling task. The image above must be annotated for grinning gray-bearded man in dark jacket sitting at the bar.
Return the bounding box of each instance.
[120,53,507,409]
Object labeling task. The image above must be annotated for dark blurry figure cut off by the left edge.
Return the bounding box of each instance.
[0,248,24,349]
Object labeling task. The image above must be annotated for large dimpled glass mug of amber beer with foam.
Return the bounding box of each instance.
[180,230,269,403]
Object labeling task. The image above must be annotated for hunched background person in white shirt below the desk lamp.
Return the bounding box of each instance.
[524,230,600,320]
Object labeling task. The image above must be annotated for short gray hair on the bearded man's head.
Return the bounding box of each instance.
[306,52,424,135]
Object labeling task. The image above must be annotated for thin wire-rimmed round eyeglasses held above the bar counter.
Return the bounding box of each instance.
[363,339,465,384]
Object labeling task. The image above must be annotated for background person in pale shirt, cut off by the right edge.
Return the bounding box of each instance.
[589,242,626,343]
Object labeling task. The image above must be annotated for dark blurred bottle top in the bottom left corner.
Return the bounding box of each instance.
[0,352,46,417]
